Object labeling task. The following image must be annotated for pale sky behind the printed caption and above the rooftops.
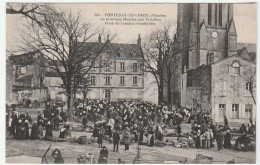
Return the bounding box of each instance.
[6,3,257,102]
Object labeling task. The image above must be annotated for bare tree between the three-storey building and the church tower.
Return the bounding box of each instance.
[143,23,185,105]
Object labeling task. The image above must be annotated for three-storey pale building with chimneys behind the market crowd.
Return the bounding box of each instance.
[79,35,144,101]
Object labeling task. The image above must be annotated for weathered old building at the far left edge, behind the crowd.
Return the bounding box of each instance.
[7,52,47,103]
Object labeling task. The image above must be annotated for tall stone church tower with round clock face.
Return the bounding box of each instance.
[177,3,237,69]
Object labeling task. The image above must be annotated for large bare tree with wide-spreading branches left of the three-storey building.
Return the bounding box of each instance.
[14,5,113,119]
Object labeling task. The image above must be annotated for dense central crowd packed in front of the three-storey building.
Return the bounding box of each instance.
[75,100,190,150]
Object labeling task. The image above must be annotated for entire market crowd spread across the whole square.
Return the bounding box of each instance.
[6,100,255,162]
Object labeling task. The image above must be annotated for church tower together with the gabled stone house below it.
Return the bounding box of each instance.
[173,3,256,123]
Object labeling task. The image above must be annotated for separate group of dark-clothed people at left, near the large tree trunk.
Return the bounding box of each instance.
[6,103,71,140]
